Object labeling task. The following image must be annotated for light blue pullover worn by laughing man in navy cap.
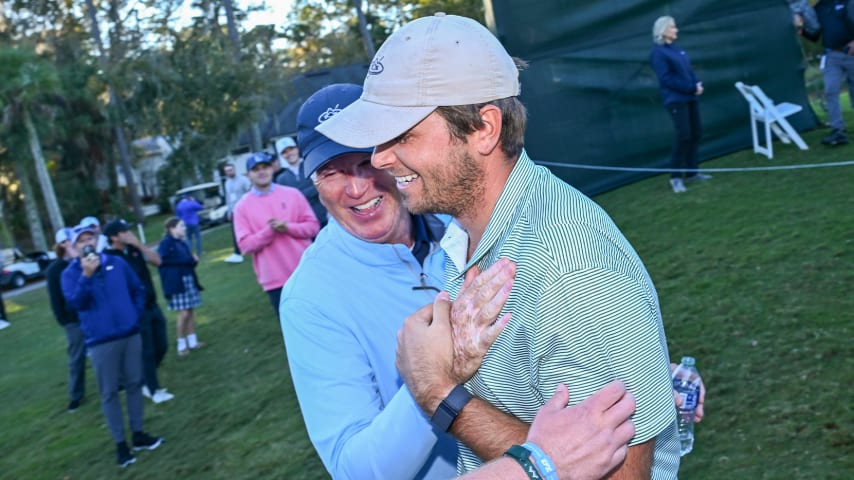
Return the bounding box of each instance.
[280,219,457,480]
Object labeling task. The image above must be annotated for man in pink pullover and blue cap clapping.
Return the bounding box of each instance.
[234,152,320,317]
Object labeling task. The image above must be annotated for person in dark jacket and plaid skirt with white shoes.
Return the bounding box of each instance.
[157,217,204,356]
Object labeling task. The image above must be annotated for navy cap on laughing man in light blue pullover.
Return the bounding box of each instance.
[297,83,374,177]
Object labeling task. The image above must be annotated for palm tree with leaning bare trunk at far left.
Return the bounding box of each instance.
[0,44,65,249]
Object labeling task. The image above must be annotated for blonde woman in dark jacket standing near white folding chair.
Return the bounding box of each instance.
[650,16,712,193]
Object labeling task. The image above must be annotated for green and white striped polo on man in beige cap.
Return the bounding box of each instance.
[442,152,679,479]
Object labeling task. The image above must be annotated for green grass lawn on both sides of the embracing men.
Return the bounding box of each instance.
[0,118,854,480]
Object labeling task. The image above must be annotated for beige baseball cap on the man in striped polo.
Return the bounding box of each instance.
[316,13,520,148]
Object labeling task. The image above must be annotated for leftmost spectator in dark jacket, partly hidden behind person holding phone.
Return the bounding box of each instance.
[45,228,86,412]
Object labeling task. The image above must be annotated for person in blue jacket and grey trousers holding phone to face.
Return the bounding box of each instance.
[62,226,163,467]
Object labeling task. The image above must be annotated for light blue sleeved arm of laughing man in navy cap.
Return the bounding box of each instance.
[281,297,444,480]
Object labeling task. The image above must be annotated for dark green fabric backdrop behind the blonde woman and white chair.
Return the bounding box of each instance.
[492,0,816,194]
